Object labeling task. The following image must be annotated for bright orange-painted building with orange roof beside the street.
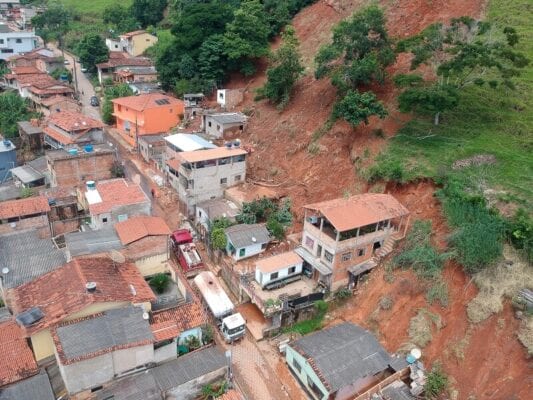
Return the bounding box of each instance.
[113,93,184,146]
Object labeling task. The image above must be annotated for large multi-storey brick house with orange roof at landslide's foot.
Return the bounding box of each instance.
[296,193,410,290]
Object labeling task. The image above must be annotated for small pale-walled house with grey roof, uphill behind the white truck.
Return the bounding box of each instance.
[224,224,270,261]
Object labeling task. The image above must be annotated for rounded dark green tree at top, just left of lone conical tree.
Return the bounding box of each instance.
[224,0,270,75]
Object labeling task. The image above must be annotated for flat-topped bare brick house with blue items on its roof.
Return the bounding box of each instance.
[46,144,116,187]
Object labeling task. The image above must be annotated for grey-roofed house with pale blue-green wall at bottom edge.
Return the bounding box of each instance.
[285,323,410,400]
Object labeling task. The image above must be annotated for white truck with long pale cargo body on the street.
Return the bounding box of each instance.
[194,271,246,343]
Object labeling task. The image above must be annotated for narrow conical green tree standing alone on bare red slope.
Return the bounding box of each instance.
[258,25,304,107]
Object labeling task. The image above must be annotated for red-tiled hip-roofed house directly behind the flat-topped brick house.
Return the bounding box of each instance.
[43,110,105,149]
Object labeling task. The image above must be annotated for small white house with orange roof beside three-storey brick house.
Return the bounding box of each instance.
[255,251,303,289]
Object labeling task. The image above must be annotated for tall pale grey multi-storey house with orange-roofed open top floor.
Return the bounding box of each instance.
[166,147,247,216]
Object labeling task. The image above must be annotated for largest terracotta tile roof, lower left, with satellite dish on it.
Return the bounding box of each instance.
[7,257,155,335]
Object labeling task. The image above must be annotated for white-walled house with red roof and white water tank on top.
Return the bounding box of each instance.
[78,178,152,230]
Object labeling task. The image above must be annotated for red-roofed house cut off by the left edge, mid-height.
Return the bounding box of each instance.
[0,196,50,238]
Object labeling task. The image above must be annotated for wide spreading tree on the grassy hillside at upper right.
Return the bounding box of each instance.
[396,17,529,125]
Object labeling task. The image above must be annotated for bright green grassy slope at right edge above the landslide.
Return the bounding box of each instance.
[372,0,533,205]
